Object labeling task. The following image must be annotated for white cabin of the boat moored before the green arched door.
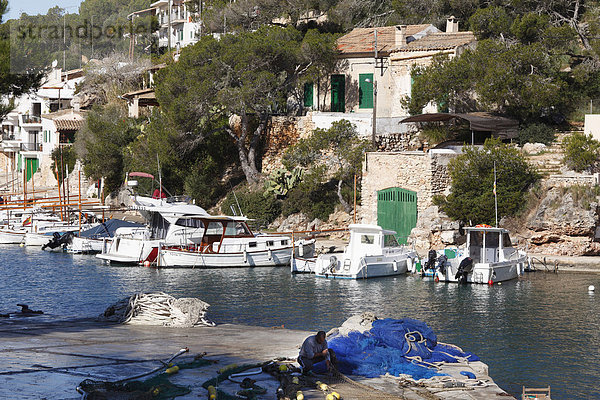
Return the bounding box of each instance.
[345,224,400,257]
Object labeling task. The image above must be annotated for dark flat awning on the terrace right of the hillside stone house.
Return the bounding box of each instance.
[400,112,519,139]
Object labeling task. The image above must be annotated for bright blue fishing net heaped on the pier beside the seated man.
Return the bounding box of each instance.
[328,319,479,380]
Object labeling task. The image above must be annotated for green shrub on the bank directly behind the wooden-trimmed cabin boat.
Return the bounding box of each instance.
[221,191,281,223]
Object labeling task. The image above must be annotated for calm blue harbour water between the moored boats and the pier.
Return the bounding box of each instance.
[0,247,600,399]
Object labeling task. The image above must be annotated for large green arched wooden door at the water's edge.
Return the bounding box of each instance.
[377,188,417,243]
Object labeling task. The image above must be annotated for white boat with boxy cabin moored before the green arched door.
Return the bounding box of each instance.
[308,224,418,279]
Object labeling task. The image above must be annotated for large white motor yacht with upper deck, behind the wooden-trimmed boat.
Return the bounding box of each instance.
[96,197,208,264]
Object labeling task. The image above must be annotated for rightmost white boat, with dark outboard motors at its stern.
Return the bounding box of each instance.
[422,226,528,284]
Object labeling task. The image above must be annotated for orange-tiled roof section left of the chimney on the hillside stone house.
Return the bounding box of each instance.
[337,24,432,54]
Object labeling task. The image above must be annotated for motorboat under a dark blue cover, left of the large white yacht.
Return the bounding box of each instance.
[66,218,144,254]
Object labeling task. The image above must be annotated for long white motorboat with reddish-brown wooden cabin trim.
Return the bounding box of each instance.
[157,215,314,268]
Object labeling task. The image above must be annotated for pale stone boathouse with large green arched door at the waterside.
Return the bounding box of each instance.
[359,149,460,250]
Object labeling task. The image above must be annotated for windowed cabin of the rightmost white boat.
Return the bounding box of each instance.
[465,226,514,264]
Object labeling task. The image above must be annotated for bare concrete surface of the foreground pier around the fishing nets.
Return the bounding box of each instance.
[0,316,513,400]
